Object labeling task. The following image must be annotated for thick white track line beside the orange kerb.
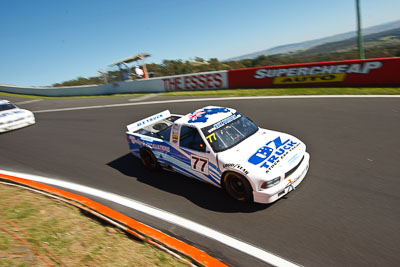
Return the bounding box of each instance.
[0,170,299,267]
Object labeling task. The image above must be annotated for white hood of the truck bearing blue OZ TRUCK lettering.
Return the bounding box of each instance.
[218,128,306,181]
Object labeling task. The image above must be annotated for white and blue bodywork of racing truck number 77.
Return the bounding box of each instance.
[126,106,310,203]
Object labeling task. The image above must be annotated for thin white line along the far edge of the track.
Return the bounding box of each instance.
[33,95,400,113]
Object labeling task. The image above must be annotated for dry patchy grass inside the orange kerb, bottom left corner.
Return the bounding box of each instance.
[0,184,188,267]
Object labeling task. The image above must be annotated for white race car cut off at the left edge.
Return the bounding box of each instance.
[0,99,35,133]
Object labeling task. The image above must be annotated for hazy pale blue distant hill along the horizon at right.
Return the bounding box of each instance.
[224,20,400,61]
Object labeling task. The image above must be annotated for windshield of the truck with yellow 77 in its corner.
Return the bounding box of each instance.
[201,112,258,152]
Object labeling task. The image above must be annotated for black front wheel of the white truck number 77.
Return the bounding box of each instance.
[223,172,253,202]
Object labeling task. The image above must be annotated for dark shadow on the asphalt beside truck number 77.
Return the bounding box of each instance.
[107,153,270,213]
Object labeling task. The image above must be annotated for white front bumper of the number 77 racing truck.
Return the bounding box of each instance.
[253,152,310,204]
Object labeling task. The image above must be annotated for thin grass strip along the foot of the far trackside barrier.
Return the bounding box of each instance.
[0,87,400,99]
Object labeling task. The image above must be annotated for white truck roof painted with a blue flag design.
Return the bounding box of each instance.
[179,106,236,128]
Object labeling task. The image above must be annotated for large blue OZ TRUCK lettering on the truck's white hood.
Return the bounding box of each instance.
[248,137,300,173]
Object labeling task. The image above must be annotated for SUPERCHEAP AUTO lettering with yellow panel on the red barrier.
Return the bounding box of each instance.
[254,61,383,84]
